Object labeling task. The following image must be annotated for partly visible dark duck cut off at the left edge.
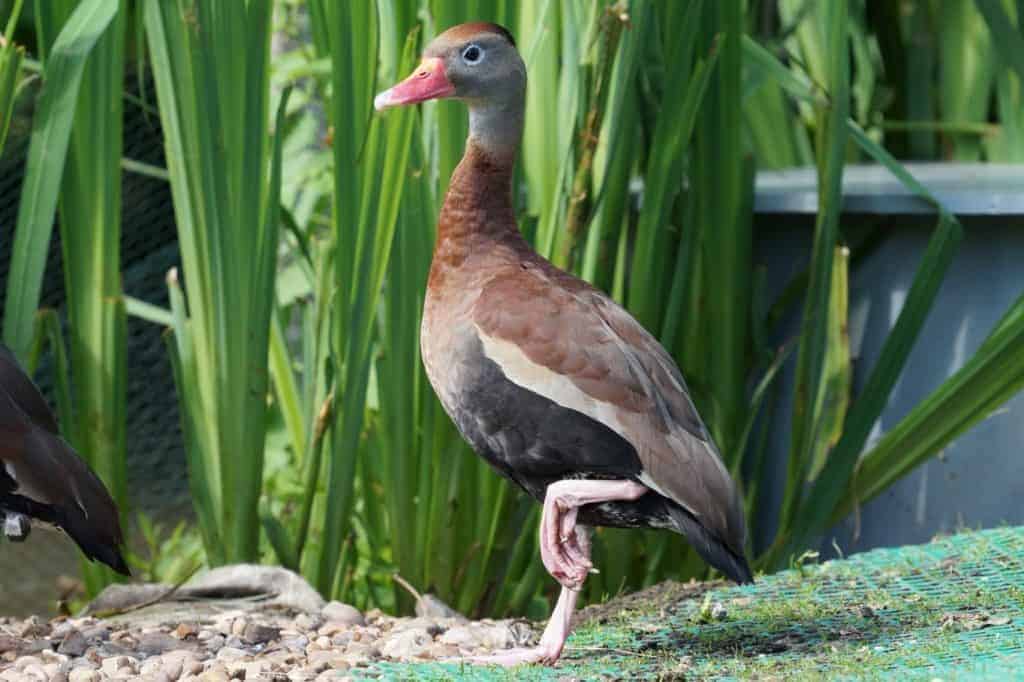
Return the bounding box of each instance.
[0,345,131,576]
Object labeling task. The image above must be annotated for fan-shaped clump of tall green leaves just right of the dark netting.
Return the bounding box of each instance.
[142,0,287,565]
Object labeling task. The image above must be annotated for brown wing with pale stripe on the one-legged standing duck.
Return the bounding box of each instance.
[472,264,745,558]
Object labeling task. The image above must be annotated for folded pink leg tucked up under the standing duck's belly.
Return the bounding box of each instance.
[541,480,647,590]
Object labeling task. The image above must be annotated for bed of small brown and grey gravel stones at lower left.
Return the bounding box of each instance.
[0,601,537,682]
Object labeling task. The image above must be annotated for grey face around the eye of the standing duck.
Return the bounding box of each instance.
[424,34,526,101]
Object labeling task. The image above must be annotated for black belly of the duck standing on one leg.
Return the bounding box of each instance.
[442,337,673,527]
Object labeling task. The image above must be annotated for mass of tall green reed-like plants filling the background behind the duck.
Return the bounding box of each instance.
[0,0,1024,616]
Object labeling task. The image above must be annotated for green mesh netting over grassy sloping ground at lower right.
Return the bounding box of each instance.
[361,527,1024,680]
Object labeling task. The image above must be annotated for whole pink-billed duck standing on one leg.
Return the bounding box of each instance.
[374,23,752,665]
